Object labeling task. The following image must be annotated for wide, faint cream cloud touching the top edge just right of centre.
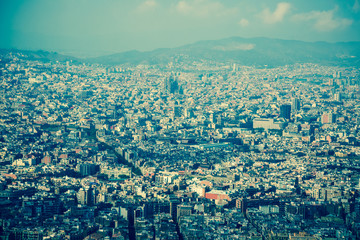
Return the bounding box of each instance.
[175,0,236,17]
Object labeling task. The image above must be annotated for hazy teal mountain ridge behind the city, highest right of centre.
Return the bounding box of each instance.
[1,37,360,67]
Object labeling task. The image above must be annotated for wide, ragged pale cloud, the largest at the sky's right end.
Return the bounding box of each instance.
[293,8,353,32]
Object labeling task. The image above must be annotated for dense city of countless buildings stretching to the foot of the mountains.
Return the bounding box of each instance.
[0,52,360,240]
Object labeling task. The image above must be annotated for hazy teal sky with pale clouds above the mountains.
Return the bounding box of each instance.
[0,0,360,55]
